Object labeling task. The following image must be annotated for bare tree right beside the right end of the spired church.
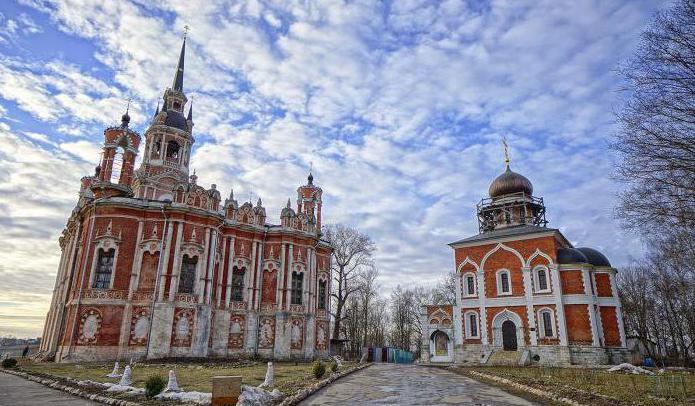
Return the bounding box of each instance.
[325,224,376,339]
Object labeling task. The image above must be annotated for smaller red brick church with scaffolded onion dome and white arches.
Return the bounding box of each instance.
[421,151,626,365]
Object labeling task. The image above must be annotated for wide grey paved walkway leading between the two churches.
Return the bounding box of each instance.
[300,364,535,406]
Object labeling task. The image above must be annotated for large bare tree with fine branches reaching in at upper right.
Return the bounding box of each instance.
[612,0,695,231]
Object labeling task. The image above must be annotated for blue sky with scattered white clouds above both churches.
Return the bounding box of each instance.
[0,0,666,336]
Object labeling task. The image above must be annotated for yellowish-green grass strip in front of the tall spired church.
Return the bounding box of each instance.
[20,361,353,395]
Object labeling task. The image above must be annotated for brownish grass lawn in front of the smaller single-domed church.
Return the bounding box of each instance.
[458,367,695,406]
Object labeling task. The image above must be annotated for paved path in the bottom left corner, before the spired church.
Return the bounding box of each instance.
[0,372,98,406]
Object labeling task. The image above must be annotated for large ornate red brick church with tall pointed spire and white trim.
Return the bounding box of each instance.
[41,38,331,361]
